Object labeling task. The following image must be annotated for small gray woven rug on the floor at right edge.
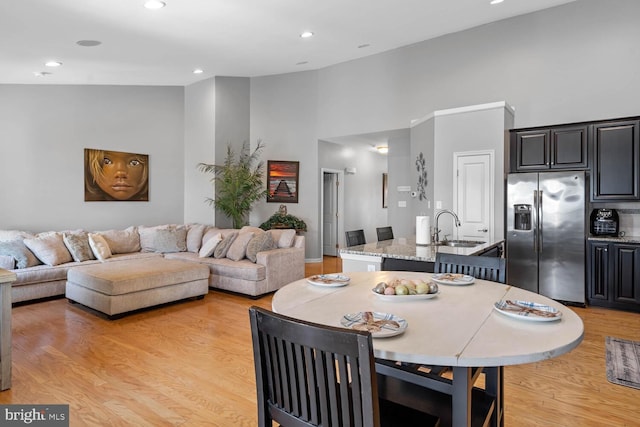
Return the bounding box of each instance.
[606,337,640,389]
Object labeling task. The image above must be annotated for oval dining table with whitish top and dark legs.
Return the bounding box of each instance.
[272,271,584,427]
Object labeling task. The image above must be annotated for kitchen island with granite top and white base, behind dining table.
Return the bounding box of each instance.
[340,237,504,273]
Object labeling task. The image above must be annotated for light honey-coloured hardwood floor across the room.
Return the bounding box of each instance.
[0,258,640,427]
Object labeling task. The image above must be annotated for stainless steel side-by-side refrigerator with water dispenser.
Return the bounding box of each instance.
[505,171,586,304]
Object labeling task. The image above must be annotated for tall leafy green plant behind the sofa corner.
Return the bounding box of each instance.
[198,140,267,228]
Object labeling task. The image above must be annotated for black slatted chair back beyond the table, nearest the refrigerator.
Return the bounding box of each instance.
[433,252,506,283]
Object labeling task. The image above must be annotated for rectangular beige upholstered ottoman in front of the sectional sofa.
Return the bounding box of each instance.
[66,258,209,318]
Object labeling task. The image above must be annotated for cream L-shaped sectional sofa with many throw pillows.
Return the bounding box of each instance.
[0,224,304,303]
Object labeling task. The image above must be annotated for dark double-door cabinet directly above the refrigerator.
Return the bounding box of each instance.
[511,125,589,172]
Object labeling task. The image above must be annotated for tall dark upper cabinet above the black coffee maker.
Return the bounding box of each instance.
[591,120,640,201]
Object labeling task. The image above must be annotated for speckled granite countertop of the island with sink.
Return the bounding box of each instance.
[340,237,504,262]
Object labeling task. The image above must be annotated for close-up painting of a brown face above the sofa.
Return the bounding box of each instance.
[84,148,149,201]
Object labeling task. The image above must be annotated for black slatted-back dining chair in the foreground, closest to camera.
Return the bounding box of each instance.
[249,306,439,427]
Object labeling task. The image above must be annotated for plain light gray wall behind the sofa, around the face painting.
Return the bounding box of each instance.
[0,85,185,232]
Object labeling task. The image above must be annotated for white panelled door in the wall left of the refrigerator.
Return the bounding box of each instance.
[453,150,494,242]
